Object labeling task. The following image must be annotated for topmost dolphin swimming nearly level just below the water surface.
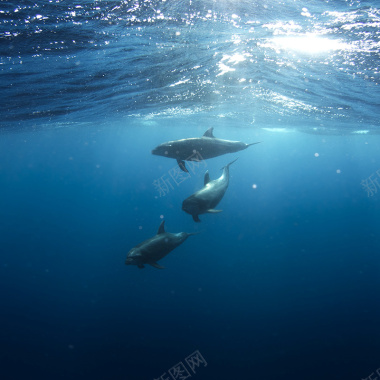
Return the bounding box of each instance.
[152,127,259,172]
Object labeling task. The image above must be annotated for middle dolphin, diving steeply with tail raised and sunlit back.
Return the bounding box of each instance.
[182,158,237,222]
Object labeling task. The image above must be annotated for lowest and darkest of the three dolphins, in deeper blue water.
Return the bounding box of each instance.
[125,220,197,269]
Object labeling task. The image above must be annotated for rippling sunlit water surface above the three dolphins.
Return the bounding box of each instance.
[0,0,380,133]
